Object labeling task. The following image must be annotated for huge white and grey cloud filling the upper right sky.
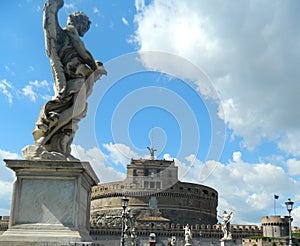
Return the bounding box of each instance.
[134,0,300,156]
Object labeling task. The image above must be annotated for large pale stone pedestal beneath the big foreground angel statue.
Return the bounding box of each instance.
[0,160,99,246]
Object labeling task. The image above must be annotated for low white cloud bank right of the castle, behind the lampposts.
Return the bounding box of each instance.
[176,152,300,225]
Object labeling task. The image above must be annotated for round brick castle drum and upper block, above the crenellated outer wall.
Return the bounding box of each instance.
[91,153,218,228]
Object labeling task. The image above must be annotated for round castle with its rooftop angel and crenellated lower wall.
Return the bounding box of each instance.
[90,151,261,245]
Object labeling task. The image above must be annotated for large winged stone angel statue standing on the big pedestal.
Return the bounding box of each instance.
[22,0,106,160]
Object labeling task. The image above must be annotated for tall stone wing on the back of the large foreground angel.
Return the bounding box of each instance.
[43,0,66,97]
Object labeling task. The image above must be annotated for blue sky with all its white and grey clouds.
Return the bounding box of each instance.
[0,0,300,225]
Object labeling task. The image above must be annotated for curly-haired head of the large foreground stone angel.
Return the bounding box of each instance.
[67,11,91,37]
